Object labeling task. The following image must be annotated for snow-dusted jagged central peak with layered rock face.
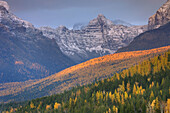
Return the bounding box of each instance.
[40,14,147,62]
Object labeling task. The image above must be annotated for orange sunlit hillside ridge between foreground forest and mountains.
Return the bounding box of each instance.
[0,46,170,102]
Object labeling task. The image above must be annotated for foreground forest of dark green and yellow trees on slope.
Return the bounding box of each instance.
[1,51,170,113]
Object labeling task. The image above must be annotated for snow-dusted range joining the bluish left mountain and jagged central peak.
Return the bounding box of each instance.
[0,1,147,83]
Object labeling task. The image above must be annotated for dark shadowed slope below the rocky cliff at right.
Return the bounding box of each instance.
[117,22,170,53]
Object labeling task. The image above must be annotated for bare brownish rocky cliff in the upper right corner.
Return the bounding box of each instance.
[148,0,170,30]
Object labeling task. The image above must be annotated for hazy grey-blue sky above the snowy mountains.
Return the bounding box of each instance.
[5,0,167,28]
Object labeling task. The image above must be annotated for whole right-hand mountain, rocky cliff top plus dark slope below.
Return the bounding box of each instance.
[117,0,170,53]
